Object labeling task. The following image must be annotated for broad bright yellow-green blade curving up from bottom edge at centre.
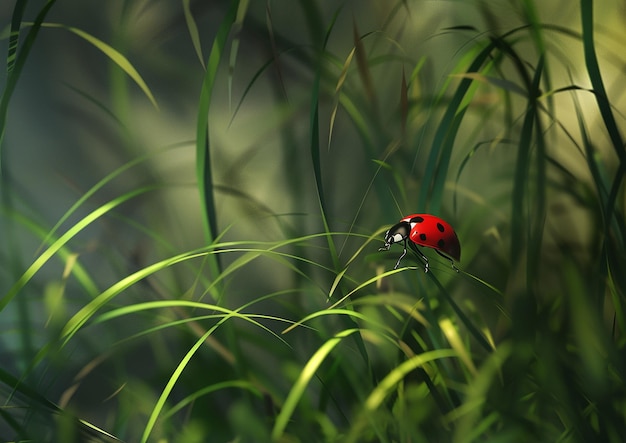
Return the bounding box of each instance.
[272,328,359,441]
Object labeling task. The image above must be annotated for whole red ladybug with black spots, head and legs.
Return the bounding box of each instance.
[379,214,461,272]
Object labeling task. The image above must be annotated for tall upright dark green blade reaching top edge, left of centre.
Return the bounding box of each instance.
[196,0,239,250]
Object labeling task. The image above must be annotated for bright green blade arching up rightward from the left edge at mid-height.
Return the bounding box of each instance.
[0,185,163,312]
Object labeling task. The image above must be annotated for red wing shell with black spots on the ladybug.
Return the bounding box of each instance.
[400,214,461,261]
